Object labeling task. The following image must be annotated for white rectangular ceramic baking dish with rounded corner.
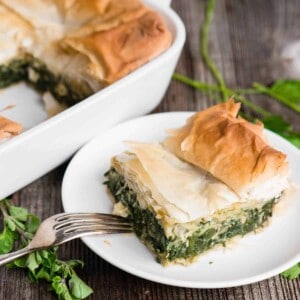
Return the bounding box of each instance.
[0,1,185,199]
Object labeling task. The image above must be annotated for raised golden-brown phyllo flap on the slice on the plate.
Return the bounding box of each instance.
[164,99,288,199]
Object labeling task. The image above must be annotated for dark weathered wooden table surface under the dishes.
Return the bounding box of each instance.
[0,0,300,300]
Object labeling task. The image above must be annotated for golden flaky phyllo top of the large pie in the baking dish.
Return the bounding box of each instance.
[0,0,172,88]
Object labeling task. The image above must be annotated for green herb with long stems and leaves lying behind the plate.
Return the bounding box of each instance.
[173,0,300,279]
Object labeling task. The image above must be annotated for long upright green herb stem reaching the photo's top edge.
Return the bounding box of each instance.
[200,0,228,101]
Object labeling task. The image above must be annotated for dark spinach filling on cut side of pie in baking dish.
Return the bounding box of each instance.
[0,55,89,106]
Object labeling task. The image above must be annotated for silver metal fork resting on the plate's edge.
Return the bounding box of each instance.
[0,213,132,266]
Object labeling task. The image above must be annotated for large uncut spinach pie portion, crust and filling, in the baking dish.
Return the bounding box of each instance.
[0,0,172,106]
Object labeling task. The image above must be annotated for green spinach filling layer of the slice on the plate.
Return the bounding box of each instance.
[105,168,276,264]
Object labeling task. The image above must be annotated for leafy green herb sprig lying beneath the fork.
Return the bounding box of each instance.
[0,199,93,300]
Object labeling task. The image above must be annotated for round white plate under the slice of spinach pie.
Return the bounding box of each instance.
[62,112,300,288]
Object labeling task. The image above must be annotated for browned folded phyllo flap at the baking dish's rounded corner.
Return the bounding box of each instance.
[63,11,172,84]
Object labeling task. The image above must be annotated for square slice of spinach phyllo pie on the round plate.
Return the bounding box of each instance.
[106,100,290,265]
